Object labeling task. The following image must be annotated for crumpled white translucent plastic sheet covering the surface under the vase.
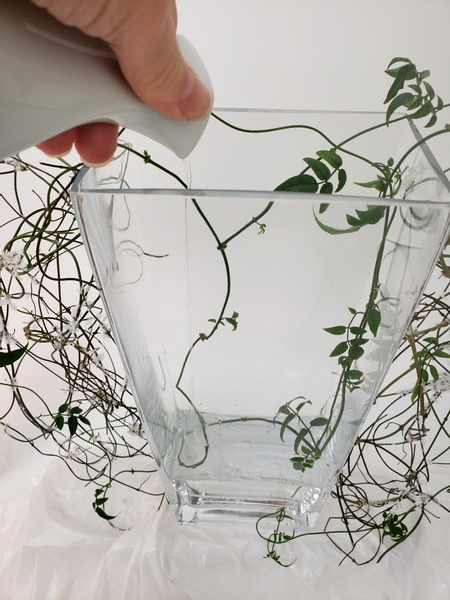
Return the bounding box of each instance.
[0,432,450,600]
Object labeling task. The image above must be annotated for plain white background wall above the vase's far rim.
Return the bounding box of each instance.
[178,0,450,111]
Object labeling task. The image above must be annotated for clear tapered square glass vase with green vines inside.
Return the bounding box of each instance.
[72,110,450,526]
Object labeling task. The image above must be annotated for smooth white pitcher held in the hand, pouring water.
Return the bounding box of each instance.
[0,0,212,159]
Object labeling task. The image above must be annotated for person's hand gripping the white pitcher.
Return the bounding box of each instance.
[31,0,211,165]
